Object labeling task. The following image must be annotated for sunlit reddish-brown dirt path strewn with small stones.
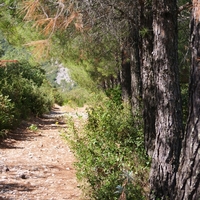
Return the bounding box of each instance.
[0,106,85,200]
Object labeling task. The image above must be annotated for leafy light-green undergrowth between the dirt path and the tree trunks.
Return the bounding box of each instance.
[66,100,148,200]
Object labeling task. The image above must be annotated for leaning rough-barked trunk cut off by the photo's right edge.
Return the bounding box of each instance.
[176,0,200,200]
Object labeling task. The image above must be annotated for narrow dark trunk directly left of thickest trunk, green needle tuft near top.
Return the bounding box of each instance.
[140,1,156,157]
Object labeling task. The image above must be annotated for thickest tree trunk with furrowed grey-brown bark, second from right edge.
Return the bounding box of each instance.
[150,0,182,199]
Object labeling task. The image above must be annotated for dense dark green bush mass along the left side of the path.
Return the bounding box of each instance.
[0,62,54,130]
